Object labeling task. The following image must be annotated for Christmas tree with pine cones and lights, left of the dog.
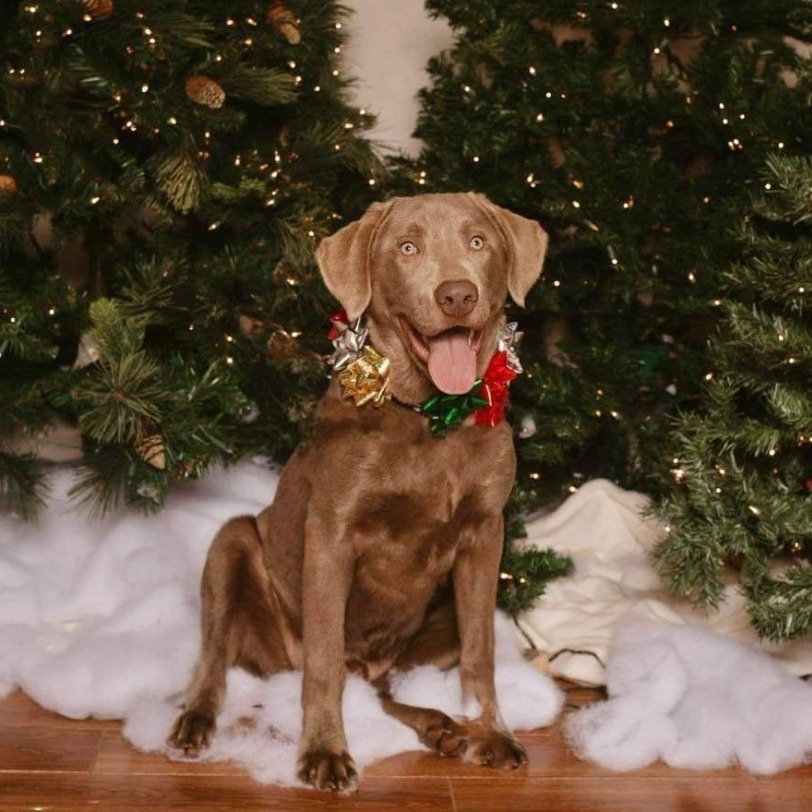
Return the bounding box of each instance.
[0,0,383,515]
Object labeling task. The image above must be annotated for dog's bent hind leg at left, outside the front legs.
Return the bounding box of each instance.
[167,516,291,756]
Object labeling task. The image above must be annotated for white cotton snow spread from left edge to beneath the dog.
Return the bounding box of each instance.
[0,462,562,784]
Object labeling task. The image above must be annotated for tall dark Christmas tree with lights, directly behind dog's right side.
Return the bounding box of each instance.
[401,0,812,510]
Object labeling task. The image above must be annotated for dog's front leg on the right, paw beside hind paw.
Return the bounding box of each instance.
[454,514,527,768]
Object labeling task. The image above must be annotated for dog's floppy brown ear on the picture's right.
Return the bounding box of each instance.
[469,192,547,307]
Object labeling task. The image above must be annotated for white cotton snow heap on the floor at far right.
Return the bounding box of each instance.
[566,618,812,774]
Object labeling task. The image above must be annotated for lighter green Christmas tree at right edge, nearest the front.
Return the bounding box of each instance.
[657,156,812,640]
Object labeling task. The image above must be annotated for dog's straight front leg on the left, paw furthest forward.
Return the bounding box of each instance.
[297,519,357,791]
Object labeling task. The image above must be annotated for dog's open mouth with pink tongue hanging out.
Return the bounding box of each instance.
[401,319,482,395]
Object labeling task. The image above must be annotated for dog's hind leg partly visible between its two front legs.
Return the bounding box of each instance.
[373,595,468,757]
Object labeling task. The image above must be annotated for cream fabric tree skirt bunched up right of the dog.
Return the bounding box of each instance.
[519,479,812,685]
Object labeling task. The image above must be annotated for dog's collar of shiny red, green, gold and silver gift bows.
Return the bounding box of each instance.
[327,311,522,437]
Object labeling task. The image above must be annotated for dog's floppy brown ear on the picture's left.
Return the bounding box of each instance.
[316,201,392,321]
